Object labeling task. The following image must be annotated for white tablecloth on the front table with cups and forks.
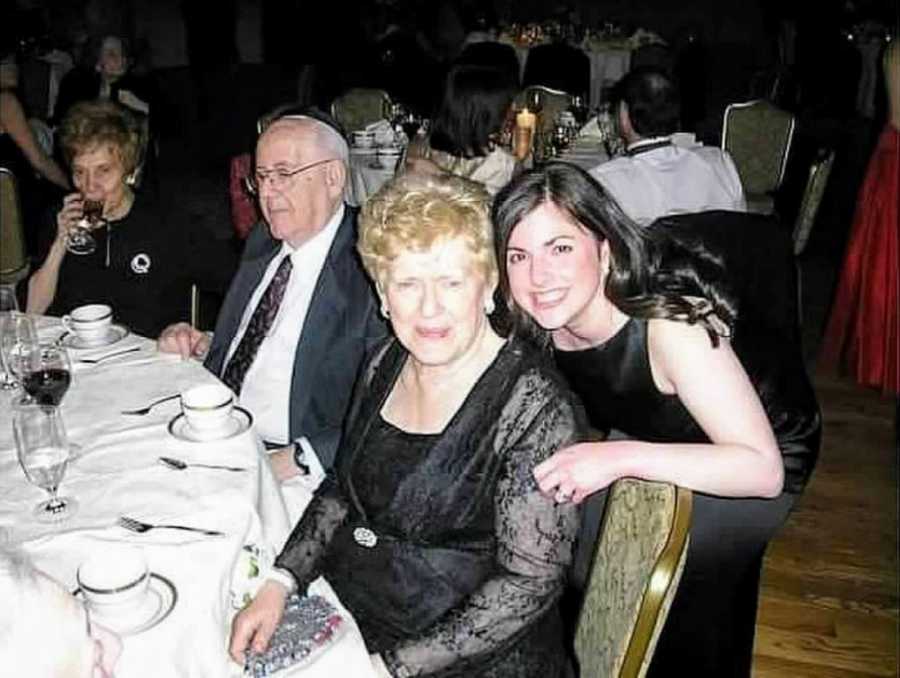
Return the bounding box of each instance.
[0,318,371,678]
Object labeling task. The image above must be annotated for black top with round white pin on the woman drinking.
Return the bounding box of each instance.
[39,194,190,337]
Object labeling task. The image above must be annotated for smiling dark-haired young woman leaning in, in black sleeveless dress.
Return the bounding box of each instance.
[493,163,820,678]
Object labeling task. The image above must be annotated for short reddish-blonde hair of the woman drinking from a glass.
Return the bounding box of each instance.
[60,101,144,176]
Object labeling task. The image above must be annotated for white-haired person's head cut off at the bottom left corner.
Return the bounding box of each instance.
[0,547,122,678]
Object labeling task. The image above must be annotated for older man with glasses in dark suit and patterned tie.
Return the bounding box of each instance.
[159,110,387,479]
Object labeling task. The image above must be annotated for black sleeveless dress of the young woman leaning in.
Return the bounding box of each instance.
[555,319,820,678]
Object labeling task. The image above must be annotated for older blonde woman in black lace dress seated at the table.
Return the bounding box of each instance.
[231,175,581,678]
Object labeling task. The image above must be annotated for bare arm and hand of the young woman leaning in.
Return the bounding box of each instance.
[535,320,784,502]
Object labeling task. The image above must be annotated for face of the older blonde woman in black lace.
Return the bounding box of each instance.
[380,238,494,367]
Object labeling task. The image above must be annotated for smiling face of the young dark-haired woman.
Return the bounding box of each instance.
[506,203,608,331]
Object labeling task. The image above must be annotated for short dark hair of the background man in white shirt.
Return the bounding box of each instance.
[611,66,681,137]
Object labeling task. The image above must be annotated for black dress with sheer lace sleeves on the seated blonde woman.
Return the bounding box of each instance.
[276,340,584,678]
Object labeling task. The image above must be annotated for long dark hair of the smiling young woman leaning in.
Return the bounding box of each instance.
[491,162,737,346]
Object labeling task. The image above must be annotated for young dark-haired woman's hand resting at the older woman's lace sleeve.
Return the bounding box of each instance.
[534,441,627,504]
